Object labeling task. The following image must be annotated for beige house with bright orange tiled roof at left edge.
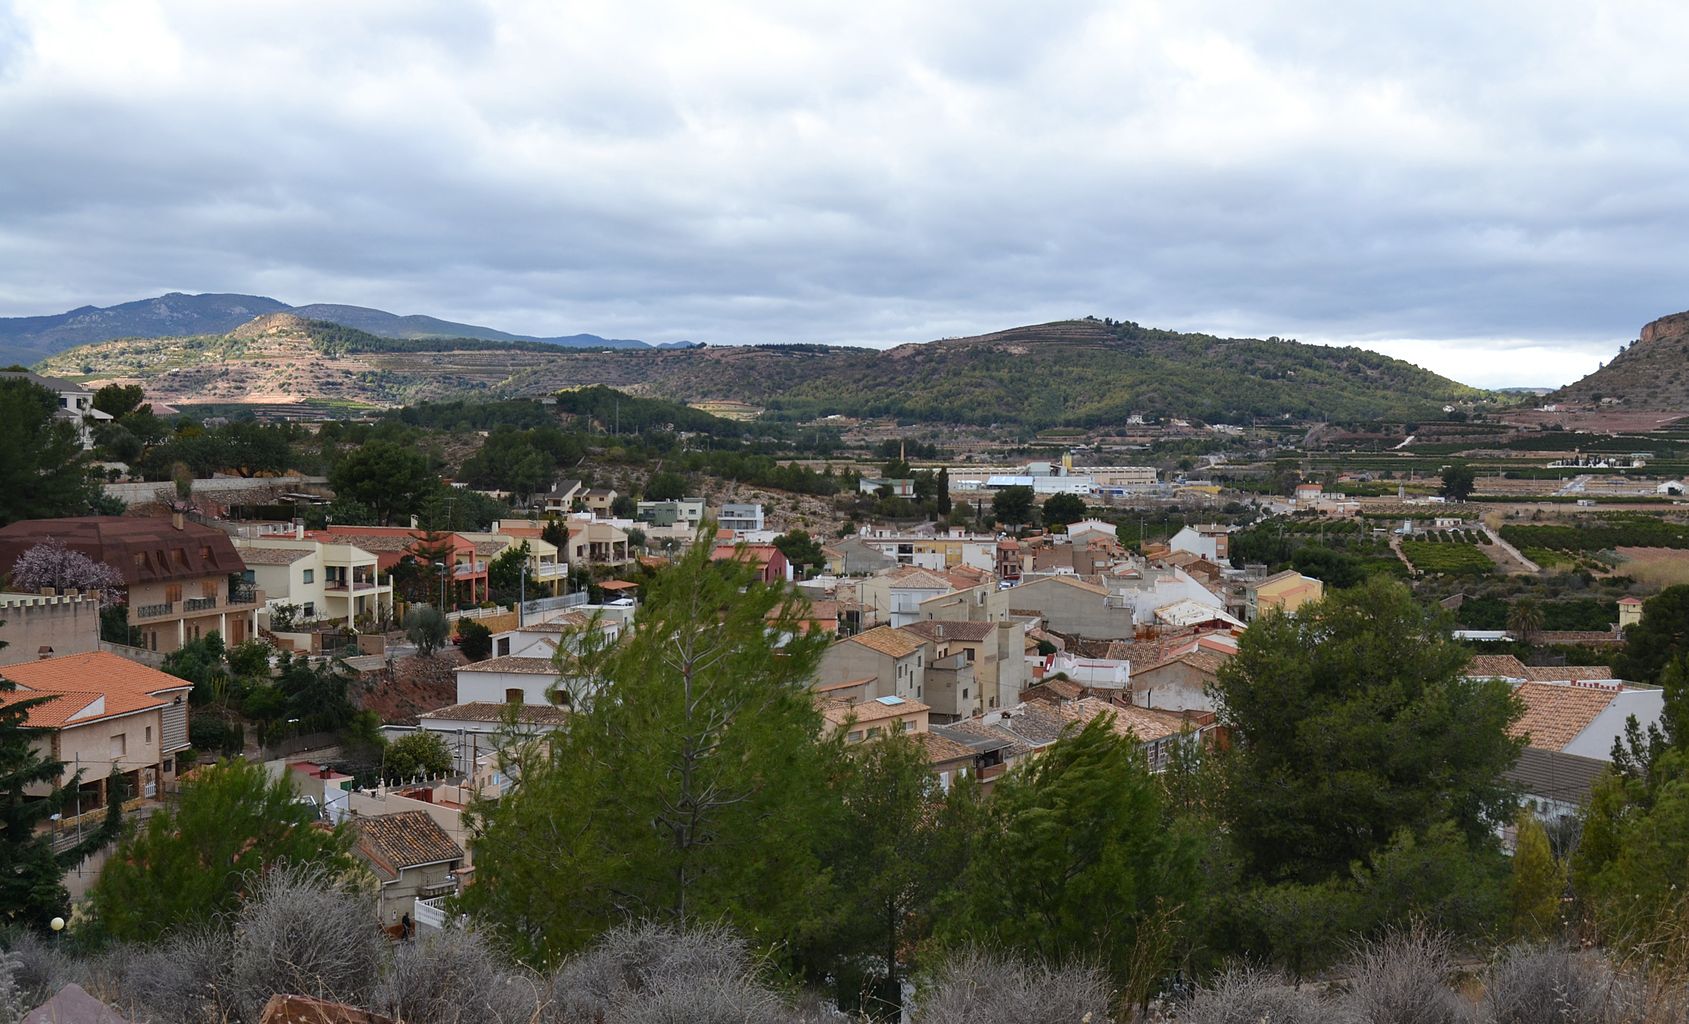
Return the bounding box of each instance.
[0,651,193,817]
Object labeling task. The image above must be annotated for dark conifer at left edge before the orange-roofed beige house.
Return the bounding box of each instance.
[0,662,123,929]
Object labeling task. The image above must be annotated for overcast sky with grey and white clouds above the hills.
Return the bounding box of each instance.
[0,0,1689,385]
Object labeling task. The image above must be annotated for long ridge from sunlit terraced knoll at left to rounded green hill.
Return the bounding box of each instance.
[41,313,1488,429]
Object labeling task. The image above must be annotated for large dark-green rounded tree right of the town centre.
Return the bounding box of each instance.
[1216,580,1522,882]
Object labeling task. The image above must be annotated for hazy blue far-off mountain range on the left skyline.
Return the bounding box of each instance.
[0,292,651,365]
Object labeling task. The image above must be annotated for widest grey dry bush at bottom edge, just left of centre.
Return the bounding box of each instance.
[546,924,794,1024]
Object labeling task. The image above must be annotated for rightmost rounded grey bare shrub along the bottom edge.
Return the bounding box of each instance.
[1483,946,1645,1024]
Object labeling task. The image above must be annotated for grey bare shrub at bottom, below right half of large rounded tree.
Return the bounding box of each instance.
[1346,928,1473,1024]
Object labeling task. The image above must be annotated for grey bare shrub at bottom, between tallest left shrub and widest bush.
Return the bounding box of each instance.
[375,928,540,1024]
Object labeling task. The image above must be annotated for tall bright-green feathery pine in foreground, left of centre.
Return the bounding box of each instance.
[463,537,839,963]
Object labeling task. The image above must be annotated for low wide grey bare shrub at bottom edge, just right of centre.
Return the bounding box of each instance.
[915,950,1113,1024]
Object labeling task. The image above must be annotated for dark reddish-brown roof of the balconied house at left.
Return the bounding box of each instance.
[0,515,247,586]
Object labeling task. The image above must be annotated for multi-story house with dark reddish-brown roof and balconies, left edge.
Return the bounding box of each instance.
[0,514,263,654]
